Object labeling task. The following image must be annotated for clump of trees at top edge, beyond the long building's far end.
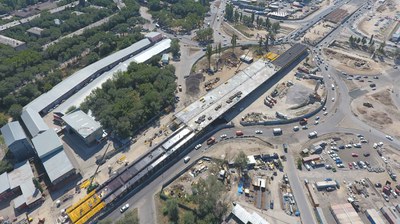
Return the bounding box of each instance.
[148,0,209,31]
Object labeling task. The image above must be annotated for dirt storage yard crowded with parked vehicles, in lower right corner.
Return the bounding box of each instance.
[299,133,400,223]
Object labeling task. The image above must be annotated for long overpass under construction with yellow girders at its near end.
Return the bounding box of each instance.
[66,44,306,224]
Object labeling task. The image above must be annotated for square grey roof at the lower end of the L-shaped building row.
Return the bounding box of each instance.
[42,150,75,182]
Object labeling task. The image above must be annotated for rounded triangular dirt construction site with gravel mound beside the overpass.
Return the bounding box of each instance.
[237,54,327,122]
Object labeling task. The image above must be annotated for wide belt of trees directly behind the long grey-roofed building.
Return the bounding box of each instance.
[0,1,143,117]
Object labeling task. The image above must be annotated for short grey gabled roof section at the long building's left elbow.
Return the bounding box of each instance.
[21,108,49,137]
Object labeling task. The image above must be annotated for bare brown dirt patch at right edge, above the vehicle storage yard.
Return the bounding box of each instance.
[351,88,400,137]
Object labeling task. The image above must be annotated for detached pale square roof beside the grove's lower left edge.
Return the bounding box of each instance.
[62,110,101,138]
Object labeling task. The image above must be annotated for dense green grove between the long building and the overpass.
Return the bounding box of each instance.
[81,63,176,138]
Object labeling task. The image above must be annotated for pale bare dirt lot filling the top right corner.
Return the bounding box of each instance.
[358,0,400,41]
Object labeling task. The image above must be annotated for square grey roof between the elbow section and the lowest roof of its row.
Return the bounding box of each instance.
[32,129,63,159]
